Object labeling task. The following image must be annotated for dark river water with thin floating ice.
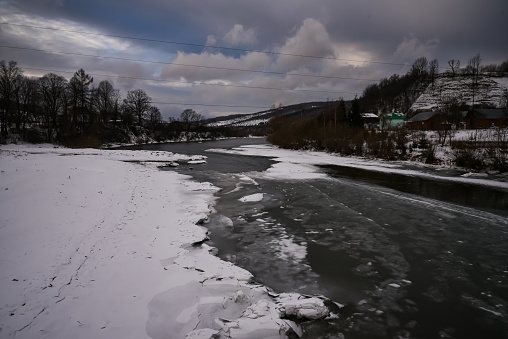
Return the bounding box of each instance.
[120,139,508,339]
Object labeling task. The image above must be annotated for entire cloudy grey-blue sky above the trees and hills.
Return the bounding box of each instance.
[0,0,508,118]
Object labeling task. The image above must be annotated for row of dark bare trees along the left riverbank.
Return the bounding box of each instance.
[0,60,228,146]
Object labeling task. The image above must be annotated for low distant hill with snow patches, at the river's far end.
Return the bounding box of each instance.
[204,101,349,129]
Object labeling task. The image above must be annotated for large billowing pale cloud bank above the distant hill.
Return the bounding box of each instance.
[161,19,380,115]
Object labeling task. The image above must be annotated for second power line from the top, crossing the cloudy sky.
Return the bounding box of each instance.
[0,45,378,82]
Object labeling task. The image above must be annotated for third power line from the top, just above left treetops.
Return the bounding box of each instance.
[22,67,356,94]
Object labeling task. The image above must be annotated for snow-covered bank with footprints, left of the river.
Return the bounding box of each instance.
[0,145,327,338]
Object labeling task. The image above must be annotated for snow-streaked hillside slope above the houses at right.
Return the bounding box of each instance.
[410,75,508,112]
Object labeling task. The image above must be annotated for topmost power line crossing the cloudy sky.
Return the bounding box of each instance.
[0,22,409,67]
